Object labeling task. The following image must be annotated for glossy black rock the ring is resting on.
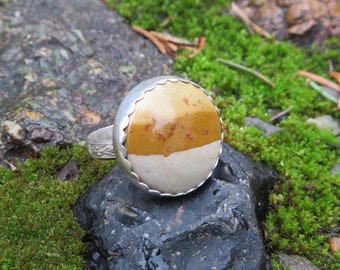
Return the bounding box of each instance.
[75,142,276,270]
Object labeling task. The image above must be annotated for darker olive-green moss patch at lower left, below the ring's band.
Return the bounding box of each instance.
[0,146,112,269]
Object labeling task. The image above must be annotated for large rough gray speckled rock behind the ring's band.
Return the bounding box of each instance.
[0,0,173,164]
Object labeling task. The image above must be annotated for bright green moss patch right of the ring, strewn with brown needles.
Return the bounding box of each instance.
[109,0,340,269]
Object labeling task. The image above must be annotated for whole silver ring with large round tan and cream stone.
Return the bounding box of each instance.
[86,76,223,197]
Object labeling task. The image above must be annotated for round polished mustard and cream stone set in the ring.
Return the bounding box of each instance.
[120,77,222,194]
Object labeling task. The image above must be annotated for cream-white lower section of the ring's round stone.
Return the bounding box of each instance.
[128,140,221,195]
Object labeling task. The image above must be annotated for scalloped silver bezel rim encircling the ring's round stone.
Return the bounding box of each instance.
[112,76,223,197]
